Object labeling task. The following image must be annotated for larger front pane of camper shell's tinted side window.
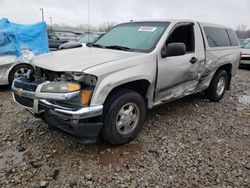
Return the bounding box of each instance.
[204,27,231,47]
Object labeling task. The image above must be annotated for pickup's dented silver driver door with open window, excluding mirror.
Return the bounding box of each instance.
[156,22,205,103]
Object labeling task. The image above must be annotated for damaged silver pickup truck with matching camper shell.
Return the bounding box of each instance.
[12,20,241,145]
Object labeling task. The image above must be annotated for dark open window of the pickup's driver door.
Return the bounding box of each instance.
[166,24,195,53]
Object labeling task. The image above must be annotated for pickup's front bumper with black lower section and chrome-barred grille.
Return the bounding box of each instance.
[12,79,103,143]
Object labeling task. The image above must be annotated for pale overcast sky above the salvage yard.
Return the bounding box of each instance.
[0,0,250,29]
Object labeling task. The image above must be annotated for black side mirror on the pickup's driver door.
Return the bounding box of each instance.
[161,43,186,58]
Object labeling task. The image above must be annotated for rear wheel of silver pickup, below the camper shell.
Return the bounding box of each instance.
[206,70,229,102]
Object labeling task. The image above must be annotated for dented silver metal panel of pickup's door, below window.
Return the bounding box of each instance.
[157,54,199,102]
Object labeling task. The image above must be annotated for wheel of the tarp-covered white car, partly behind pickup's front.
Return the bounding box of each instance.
[9,64,33,85]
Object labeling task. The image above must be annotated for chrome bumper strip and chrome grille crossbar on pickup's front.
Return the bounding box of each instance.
[11,80,103,120]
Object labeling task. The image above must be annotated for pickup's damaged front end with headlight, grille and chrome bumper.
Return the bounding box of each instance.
[12,68,103,143]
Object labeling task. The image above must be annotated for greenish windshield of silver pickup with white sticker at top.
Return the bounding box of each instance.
[93,22,169,52]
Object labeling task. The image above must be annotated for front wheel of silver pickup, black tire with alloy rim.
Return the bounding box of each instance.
[101,89,146,145]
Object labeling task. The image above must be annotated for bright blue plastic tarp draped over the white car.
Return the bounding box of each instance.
[0,18,49,56]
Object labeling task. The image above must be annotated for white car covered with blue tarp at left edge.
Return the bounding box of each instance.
[0,18,48,85]
